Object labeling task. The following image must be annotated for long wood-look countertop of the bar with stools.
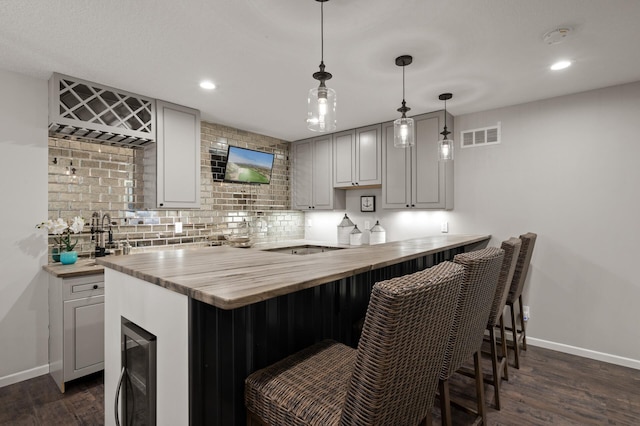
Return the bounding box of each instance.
[96,235,490,309]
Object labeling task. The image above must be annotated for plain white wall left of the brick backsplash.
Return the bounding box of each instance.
[0,70,49,387]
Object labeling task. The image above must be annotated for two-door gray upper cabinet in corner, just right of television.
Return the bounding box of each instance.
[291,135,345,210]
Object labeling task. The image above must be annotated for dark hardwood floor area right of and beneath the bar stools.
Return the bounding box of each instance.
[433,345,640,426]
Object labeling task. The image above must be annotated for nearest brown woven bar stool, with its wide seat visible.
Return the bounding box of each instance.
[245,262,465,426]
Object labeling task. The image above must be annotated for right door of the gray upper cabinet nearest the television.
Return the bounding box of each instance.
[311,135,333,210]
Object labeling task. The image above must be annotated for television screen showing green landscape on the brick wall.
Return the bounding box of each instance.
[224,145,273,184]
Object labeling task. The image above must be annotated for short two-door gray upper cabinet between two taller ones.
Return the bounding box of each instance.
[333,124,382,188]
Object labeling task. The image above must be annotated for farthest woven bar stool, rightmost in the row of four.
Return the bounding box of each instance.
[507,232,538,368]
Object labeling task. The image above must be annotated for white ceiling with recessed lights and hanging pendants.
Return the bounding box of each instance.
[0,0,640,141]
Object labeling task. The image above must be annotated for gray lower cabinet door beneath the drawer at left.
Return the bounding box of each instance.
[63,296,104,382]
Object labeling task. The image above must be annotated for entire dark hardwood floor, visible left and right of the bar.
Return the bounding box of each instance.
[0,346,640,425]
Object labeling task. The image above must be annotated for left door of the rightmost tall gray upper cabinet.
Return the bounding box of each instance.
[382,122,411,209]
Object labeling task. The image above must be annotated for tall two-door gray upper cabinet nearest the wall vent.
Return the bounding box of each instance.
[382,111,454,210]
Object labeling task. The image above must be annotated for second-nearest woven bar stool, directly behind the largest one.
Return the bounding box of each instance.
[438,247,504,426]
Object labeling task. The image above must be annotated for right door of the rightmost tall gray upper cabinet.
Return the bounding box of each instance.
[411,111,453,209]
